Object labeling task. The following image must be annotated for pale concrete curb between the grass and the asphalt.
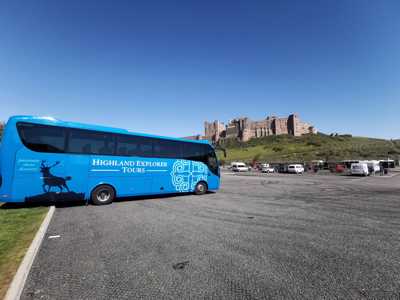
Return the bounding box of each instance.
[4,206,55,300]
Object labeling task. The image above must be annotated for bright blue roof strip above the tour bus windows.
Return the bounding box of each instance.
[7,116,210,144]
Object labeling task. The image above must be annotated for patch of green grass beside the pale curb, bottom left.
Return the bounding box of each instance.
[0,204,48,299]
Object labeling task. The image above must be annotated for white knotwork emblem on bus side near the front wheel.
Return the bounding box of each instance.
[171,160,207,192]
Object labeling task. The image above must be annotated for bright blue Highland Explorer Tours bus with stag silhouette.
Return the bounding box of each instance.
[0,116,220,204]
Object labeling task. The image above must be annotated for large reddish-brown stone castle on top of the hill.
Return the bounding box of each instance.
[204,114,317,143]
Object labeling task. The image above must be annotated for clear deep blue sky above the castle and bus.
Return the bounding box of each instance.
[0,0,400,138]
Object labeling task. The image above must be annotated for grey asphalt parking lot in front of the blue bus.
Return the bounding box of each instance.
[22,174,400,299]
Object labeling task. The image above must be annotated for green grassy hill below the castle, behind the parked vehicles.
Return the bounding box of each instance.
[218,133,400,163]
